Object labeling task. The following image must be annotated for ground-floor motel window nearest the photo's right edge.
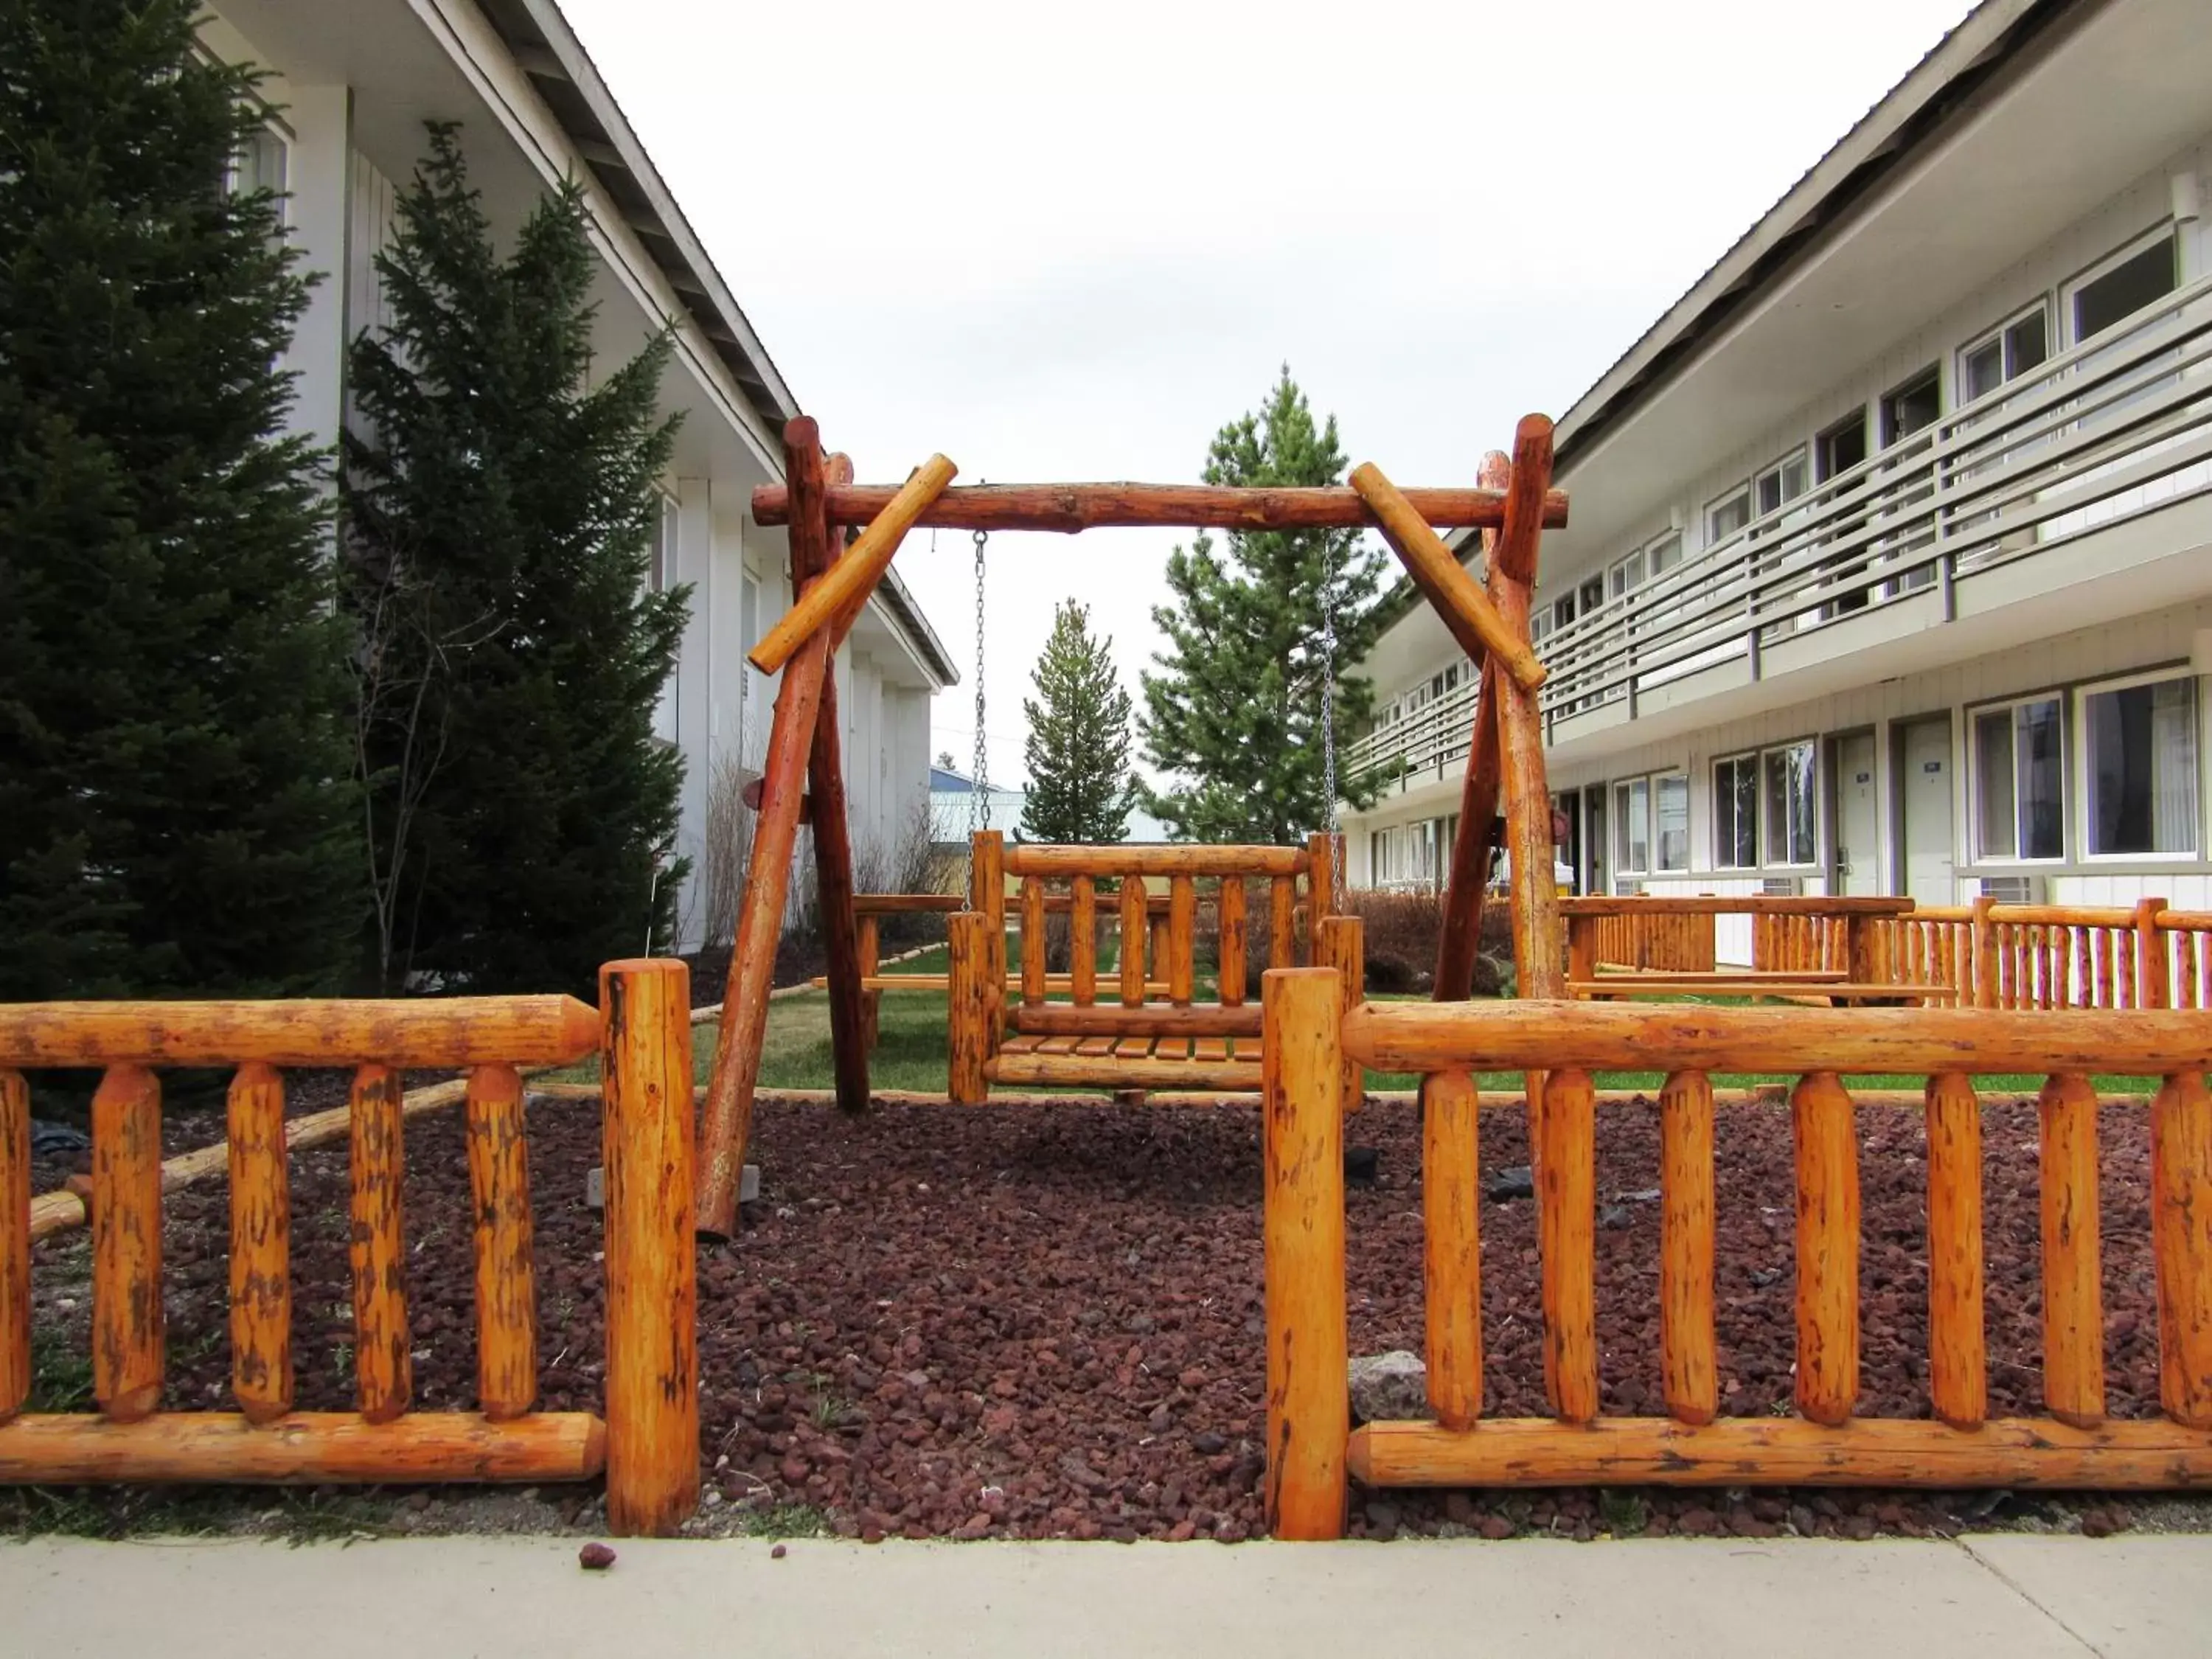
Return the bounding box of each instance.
[2077,679,2197,858]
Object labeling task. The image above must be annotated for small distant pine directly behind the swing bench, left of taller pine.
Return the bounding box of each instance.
[1022,599,1135,845]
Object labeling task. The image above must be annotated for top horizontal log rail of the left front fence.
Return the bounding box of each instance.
[0,995,599,1068]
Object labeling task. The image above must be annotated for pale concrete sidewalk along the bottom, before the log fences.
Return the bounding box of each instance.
[0,1533,2212,1659]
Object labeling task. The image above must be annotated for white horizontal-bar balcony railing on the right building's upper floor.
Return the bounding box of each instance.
[1347,279,2212,779]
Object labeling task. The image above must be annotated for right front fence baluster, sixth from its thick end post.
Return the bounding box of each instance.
[2037,1071,2104,1429]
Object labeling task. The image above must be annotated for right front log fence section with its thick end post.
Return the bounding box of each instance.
[1263,969,2212,1537]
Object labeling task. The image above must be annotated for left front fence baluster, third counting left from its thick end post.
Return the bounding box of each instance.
[226,1060,292,1422]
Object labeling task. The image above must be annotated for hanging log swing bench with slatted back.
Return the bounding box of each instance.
[949,832,1363,1104]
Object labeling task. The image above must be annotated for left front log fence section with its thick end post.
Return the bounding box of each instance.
[0,960,699,1533]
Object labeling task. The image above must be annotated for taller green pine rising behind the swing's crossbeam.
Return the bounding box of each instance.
[1144,365,1380,845]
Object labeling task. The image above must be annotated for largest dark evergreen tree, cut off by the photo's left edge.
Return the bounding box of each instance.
[0,0,363,1000]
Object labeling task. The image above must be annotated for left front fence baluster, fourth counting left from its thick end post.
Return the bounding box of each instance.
[91,1066,164,1422]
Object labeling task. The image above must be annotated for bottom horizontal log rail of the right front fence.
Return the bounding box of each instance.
[1349,1418,2212,1491]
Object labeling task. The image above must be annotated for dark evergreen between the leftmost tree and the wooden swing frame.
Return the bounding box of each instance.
[345,124,688,991]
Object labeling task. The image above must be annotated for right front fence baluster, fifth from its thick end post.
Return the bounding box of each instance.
[1927,1071,1989,1429]
